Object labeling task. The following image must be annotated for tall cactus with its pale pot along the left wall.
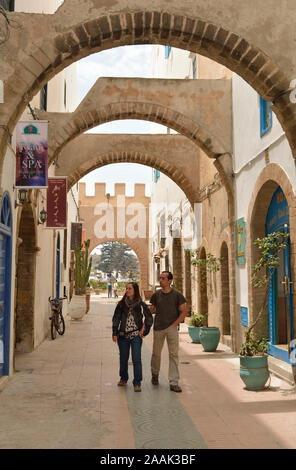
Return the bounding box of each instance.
[69,240,92,320]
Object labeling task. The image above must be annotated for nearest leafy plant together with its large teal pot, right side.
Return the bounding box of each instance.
[239,232,289,390]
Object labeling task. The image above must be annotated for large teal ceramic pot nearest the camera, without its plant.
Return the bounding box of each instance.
[239,356,269,390]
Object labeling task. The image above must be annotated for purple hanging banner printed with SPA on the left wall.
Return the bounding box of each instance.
[15,121,48,188]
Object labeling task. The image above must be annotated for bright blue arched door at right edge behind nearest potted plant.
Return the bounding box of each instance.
[265,186,294,362]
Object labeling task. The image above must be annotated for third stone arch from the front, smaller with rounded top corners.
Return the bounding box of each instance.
[56,134,201,204]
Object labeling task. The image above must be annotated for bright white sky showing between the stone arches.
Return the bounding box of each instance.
[77,45,166,196]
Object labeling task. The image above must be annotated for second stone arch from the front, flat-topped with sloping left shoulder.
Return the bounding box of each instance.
[36,78,232,162]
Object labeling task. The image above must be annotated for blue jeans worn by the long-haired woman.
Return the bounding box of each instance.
[117,336,143,385]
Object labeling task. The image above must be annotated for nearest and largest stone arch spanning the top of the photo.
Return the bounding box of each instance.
[0,0,296,167]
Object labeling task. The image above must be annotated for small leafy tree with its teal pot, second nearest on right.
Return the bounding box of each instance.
[191,249,223,352]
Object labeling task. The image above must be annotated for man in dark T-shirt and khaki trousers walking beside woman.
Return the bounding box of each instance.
[150,271,186,392]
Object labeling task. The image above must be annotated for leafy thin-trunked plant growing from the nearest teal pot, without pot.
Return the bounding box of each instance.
[240,232,289,356]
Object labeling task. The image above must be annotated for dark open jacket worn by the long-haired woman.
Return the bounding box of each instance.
[112,301,153,336]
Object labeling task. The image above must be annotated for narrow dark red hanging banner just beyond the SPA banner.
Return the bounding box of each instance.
[46,176,67,228]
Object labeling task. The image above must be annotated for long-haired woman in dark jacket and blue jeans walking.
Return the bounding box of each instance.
[112,282,153,392]
